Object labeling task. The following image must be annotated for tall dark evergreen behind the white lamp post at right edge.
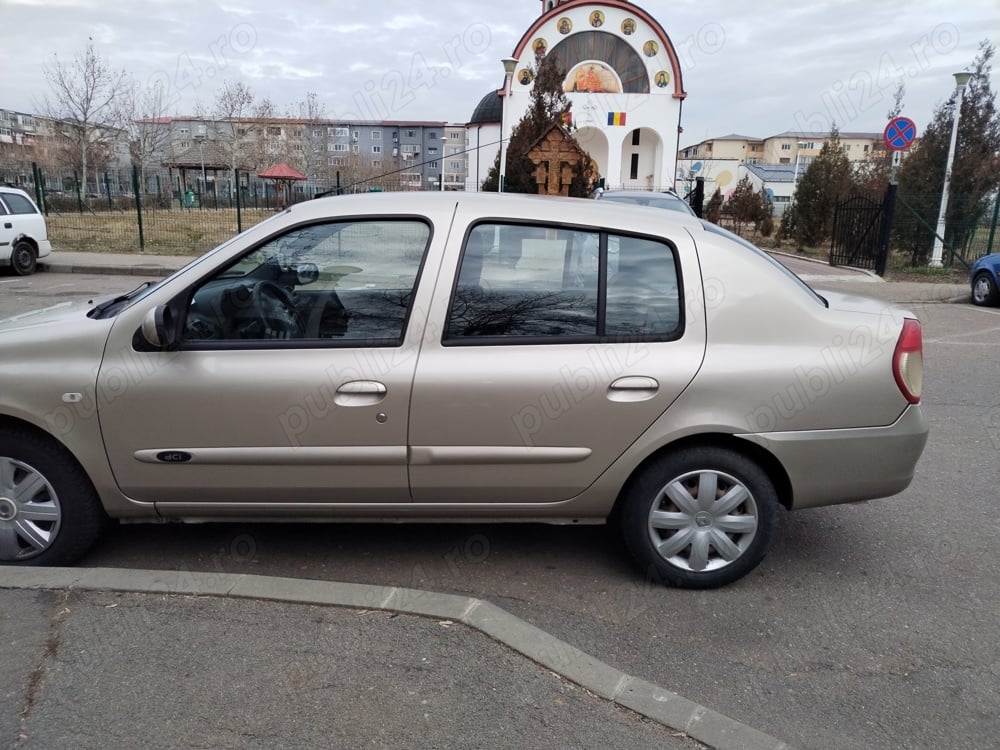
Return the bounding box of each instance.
[895,41,1000,265]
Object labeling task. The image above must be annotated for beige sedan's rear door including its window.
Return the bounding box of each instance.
[410,215,705,503]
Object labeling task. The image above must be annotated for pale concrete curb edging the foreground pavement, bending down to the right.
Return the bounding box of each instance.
[0,567,790,750]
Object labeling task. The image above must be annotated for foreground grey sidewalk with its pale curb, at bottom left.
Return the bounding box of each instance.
[0,567,788,750]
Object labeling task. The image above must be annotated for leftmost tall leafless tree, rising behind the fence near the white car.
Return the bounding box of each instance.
[43,42,128,195]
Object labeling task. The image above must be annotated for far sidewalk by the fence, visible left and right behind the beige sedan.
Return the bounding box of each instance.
[39,250,969,305]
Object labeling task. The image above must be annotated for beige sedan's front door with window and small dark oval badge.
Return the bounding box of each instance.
[98,218,433,514]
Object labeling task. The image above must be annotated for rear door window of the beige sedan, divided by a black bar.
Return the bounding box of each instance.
[444,224,683,345]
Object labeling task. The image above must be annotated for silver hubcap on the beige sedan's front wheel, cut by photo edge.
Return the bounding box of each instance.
[0,456,62,560]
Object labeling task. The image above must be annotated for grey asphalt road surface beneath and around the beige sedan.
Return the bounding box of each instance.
[0,274,1000,750]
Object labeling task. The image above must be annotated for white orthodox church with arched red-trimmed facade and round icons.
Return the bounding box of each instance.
[466,0,687,190]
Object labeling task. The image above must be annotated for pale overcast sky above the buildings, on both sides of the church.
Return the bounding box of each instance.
[0,0,1000,145]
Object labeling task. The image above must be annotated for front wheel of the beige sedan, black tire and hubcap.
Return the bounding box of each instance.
[0,430,108,565]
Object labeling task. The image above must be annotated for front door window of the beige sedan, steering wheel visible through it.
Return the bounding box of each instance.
[184,219,430,349]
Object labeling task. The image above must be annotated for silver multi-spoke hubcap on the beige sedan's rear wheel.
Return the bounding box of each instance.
[648,471,758,572]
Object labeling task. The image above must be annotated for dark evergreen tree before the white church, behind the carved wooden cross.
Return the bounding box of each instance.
[482,55,596,197]
